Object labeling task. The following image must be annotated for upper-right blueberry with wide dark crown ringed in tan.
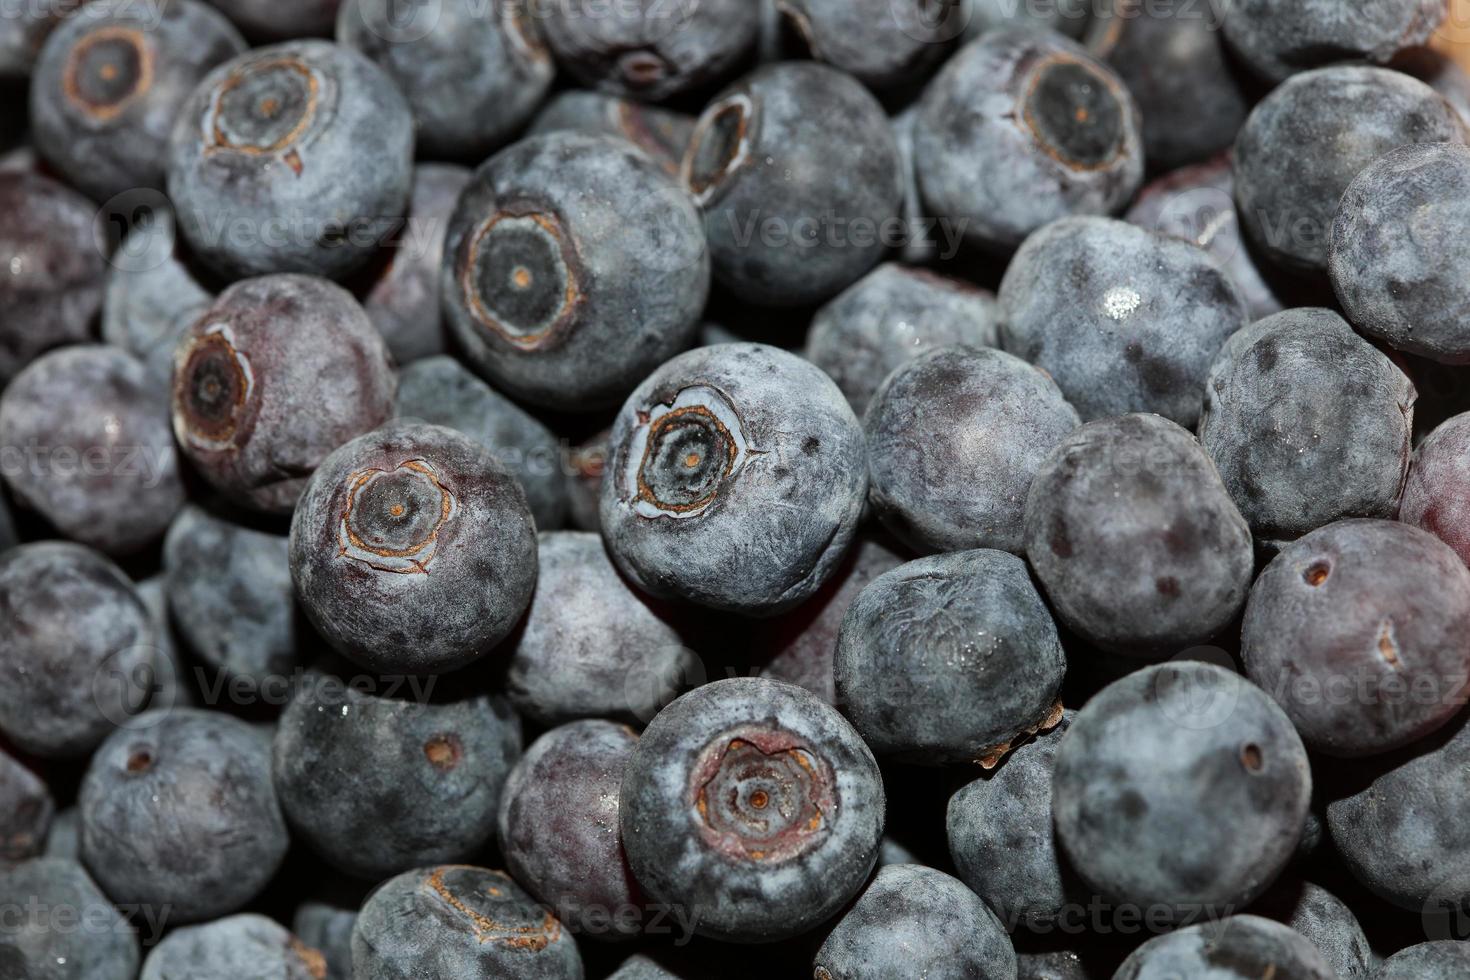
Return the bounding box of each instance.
[914,28,1144,253]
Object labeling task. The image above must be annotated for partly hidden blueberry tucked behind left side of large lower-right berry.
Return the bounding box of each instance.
[945,711,1086,932]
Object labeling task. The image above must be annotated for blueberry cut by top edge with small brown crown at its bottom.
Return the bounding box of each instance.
[538,0,759,101]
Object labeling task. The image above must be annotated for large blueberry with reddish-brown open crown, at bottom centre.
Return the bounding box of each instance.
[619,677,883,942]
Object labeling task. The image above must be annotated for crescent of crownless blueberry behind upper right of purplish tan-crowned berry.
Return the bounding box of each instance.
[397,356,567,530]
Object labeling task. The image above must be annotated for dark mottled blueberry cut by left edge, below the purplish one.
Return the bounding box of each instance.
[0,541,157,758]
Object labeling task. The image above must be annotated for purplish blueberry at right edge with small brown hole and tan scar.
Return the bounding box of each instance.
[1241,520,1470,758]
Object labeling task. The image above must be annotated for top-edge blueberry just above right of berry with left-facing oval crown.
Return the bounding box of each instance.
[776,0,964,90]
